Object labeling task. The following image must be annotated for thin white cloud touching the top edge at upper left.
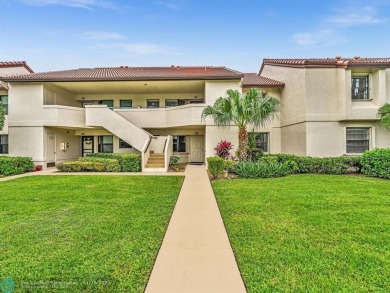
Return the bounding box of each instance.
[23,0,115,9]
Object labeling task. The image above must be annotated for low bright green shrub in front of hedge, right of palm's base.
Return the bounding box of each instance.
[236,161,292,178]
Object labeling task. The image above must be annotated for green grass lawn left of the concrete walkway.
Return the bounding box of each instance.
[0,176,183,292]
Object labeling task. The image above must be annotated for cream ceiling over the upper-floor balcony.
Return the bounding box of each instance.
[47,80,205,94]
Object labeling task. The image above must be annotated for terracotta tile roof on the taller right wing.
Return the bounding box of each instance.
[259,56,390,74]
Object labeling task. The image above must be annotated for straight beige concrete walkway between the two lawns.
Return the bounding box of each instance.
[145,165,246,293]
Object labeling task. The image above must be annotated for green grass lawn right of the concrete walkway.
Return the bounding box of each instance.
[213,175,390,292]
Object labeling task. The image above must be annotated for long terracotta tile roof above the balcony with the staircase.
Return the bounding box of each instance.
[3,66,243,81]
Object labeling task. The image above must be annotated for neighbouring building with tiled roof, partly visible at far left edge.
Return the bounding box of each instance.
[0,61,33,155]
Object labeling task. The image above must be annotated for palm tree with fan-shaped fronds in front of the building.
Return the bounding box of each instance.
[202,89,280,160]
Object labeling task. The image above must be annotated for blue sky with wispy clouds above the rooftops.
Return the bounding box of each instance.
[0,0,390,72]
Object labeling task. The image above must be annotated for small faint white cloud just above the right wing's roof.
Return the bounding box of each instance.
[292,30,344,46]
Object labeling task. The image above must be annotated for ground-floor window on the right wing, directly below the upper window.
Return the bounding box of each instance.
[346,127,370,154]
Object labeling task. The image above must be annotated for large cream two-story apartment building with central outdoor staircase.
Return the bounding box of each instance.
[3,57,390,171]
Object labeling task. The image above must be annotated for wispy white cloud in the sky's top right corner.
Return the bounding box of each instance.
[328,6,388,26]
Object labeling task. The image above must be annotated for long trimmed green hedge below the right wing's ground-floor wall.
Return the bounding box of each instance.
[259,154,362,175]
